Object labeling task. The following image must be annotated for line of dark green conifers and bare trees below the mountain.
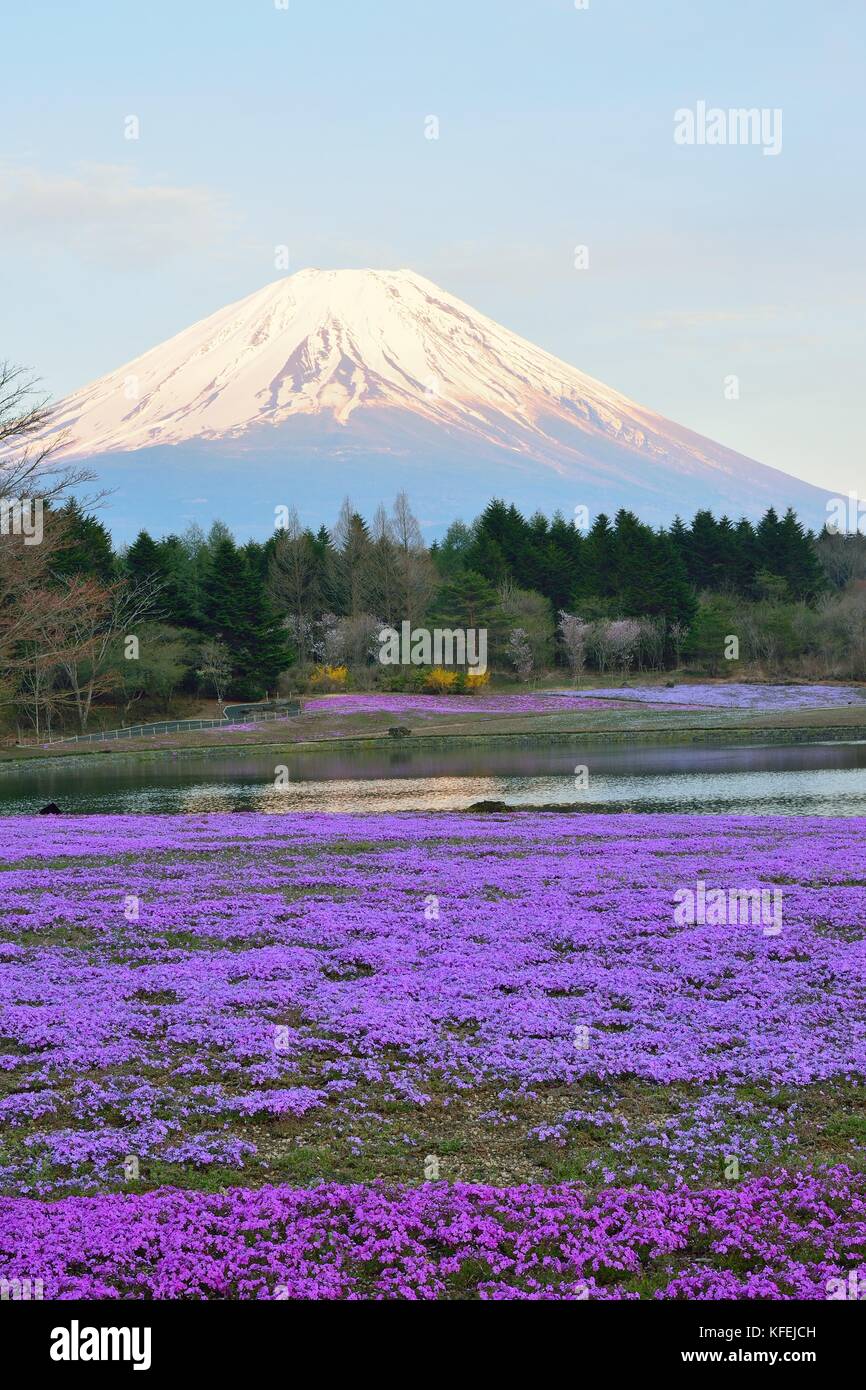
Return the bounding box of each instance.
[44,496,862,696]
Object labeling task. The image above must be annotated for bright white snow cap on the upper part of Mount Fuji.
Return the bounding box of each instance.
[45,270,670,455]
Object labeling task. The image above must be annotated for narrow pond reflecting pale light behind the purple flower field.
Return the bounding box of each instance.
[0,738,866,816]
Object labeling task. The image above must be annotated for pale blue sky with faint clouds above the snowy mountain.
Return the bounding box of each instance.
[0,0,866,491]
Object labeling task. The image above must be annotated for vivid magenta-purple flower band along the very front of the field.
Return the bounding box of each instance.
[0,1166,866,1300]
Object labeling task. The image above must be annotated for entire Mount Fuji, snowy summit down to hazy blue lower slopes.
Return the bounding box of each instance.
[38,270,830,537]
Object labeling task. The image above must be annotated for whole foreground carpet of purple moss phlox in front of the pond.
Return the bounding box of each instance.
[0,815,866,1297]
